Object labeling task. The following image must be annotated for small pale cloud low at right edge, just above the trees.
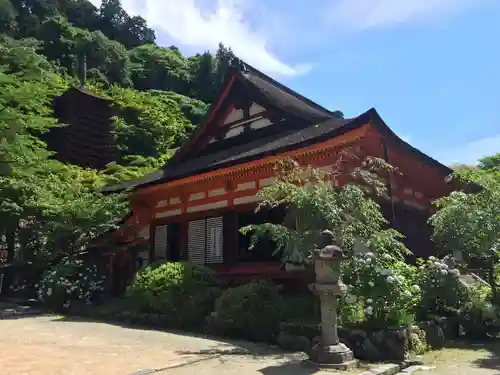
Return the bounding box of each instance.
[436,134,500,165]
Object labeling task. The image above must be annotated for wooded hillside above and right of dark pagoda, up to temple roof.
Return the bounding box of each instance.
[0,0,238,173]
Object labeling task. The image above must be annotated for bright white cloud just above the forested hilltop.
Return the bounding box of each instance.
[91,0,311,76]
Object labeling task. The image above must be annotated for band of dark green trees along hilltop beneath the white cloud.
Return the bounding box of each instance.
[0,0,234,102]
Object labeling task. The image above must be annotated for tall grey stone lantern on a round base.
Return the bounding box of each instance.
[309,230,357,369]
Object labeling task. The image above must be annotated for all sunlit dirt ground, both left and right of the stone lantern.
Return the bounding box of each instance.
[0,316,500,375]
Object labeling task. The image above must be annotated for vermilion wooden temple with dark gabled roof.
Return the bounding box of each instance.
[101,64,451,290]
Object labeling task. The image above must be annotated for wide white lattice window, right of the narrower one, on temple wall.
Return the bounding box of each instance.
[188,216,224,264]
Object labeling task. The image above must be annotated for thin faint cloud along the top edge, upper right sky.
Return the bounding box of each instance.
[327,0,489,29]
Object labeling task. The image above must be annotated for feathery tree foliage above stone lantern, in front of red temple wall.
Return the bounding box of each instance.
[242,157,409,263]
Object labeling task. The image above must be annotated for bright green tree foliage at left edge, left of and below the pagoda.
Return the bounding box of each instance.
[0,38,127,261]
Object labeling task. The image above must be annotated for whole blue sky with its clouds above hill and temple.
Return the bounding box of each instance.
[92,0,500,164]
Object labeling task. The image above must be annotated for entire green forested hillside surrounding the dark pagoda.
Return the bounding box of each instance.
[0,0,233,262]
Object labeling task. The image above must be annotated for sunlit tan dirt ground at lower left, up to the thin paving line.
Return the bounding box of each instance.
[0,316,288,375]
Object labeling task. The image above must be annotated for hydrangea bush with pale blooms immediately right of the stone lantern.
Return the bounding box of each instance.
[340,252,421,328]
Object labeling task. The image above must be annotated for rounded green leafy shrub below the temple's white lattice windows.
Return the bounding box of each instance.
[127,262,218,327]
